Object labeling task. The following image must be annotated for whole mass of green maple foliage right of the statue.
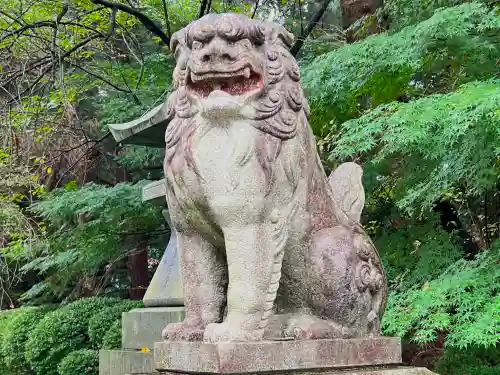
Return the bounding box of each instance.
[312,0,500,368]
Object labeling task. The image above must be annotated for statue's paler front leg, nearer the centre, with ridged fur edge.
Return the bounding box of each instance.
[204,223,282,342]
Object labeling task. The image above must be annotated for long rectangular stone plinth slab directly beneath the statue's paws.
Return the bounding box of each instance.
[154,337,401,373]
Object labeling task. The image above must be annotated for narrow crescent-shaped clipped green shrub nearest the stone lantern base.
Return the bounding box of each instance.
[89,300,143,349]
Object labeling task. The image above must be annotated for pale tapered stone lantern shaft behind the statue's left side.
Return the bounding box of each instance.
[143,210,184,307]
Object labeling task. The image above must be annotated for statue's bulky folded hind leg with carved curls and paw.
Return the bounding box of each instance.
[284,226,386,339]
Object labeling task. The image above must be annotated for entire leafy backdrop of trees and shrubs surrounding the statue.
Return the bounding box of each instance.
[0,0,500,375]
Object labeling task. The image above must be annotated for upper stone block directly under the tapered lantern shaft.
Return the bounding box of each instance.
[122,307,184,350]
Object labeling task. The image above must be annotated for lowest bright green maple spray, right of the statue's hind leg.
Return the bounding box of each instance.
[383,241,500,349]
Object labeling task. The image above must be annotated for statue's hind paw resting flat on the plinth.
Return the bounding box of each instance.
[284,316,351,340]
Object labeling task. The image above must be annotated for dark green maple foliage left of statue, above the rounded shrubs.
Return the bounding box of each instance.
[18,181,165,301]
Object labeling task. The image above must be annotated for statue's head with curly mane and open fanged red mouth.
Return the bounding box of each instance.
[167,13,307,143]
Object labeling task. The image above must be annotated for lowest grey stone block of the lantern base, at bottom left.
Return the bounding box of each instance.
[99,350,157,375]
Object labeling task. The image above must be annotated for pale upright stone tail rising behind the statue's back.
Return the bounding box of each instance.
[328,163,365,223]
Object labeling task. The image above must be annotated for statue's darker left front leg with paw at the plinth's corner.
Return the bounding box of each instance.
[163,231,227,341]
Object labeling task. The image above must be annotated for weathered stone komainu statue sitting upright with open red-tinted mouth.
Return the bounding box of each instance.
[163,14,387,342]
